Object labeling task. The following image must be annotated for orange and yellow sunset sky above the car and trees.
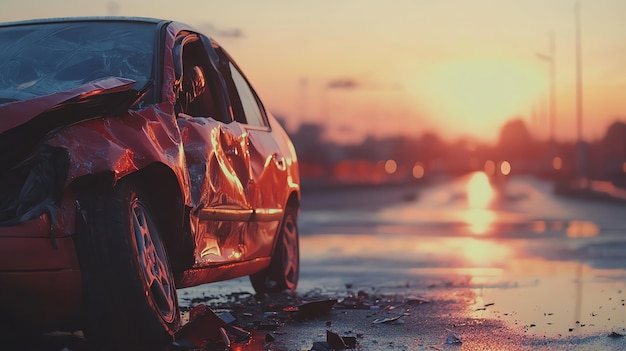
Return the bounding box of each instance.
[0,0,626,142]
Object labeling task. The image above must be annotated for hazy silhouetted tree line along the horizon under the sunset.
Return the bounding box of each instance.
[276,119,626,186]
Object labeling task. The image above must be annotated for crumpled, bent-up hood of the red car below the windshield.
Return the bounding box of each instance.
[0,77,139,134]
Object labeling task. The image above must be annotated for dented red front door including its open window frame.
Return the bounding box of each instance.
[174,34,254,268]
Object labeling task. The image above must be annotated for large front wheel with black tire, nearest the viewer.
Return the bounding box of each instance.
[77,181,180,350]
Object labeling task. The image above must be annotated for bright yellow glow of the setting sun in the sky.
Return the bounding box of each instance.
[414,58,547,138]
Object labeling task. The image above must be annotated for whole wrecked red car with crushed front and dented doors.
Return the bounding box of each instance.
[0,18,300,349]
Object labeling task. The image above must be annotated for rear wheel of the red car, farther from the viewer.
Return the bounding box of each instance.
[250,207,300,293]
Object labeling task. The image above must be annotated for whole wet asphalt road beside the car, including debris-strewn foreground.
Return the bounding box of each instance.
[8,174,626,351]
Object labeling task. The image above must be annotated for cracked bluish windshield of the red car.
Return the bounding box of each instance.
[0,21,156,104]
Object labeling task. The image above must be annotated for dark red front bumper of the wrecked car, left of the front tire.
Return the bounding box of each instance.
[0,216,82,328]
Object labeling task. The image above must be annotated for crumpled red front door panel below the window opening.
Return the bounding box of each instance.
[178,115,254,267]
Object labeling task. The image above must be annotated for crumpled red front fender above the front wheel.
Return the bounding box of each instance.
[47,103,191,203]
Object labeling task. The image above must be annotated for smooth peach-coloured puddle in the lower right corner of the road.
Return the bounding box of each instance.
[469,260,626,337]
